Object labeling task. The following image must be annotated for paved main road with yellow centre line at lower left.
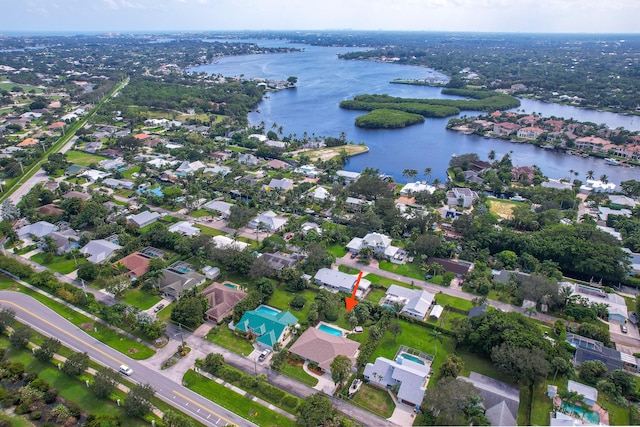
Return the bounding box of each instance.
[0,291,255,427]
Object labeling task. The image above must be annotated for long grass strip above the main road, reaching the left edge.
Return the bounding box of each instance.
[0,281,155,360]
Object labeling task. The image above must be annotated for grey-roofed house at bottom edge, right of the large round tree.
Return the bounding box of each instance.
[458,371,520,426]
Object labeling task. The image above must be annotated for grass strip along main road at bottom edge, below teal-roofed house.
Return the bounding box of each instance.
[182,370,296,427]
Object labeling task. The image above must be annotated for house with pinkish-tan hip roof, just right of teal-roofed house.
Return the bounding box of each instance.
[289,328,360,372]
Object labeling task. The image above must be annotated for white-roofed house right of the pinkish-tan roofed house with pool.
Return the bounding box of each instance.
[363,356,431,407]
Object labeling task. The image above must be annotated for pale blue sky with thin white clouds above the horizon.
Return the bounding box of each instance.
[5,0,640,34]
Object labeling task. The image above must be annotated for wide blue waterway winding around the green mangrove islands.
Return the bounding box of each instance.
[190,40,640,184]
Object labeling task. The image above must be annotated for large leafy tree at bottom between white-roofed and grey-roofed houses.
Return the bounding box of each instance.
[420,377,480,426]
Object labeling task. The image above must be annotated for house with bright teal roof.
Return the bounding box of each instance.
[235,310,298,348]
